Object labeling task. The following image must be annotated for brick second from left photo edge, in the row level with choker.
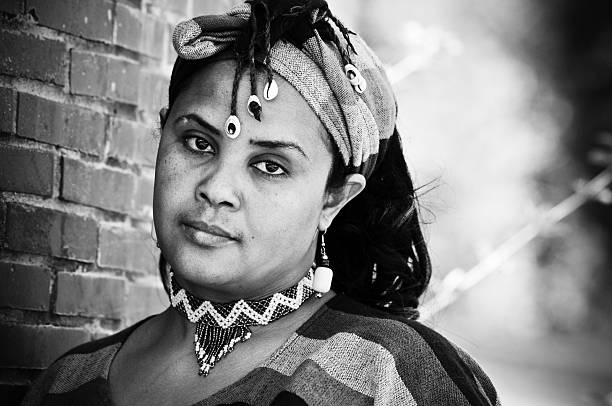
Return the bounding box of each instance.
[55,272,126,319]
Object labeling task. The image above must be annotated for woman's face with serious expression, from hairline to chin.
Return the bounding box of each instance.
[154,61,339,301]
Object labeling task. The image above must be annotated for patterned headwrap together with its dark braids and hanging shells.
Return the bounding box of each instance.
[170,0,396,178]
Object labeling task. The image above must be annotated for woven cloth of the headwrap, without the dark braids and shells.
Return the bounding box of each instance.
[173,2,397,178]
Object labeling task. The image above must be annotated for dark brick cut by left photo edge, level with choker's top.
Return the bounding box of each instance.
[0,262,51,310]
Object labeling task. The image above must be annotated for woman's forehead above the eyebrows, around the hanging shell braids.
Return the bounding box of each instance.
[170,60,328,151]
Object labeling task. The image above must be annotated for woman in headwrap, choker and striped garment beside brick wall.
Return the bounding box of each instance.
[24,0,498,405]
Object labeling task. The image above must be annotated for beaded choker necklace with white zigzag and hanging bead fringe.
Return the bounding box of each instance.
[167,269,315,376]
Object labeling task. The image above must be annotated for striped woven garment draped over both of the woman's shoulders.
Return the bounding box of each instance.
[23,295,500,406]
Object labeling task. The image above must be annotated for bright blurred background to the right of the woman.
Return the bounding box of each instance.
[340,0,612,405]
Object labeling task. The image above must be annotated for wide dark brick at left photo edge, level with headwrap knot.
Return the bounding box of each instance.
[0,32,66,85]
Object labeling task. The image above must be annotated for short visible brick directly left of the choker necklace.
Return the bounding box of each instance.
[125,280,169,325]
